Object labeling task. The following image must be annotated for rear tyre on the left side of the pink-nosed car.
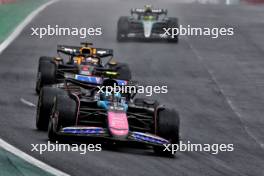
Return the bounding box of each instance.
[36,87,66,131]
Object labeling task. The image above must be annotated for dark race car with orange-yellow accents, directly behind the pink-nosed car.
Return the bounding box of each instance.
[36,43,131,93]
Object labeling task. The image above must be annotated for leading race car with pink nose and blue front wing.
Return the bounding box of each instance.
[37,79,179,156]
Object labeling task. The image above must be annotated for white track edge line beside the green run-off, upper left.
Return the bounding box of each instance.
[0,0,58,54]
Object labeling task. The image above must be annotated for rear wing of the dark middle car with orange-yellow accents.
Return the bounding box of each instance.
[57,45,114,57]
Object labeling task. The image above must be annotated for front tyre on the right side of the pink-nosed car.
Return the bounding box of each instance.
[153,109,180,156]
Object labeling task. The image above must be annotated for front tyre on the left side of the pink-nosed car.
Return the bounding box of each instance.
[48,95,77,141]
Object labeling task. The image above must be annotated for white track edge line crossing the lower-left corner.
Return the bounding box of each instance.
[0,139,70,176]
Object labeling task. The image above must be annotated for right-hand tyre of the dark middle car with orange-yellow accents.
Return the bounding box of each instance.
[112,63,132,80]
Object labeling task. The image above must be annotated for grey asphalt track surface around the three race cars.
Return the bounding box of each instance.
[0,0,264,176]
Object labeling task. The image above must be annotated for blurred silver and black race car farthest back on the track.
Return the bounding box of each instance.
[117,5,179,43]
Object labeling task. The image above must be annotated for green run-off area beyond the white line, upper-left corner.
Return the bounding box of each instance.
[0,0,48,43]
